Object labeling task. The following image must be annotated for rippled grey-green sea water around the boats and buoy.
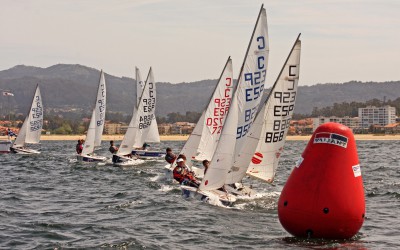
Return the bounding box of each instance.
[0,141,400,249]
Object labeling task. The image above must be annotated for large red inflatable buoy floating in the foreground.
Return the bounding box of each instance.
[278,122,365,239]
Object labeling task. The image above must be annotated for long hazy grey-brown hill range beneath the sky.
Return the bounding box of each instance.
[0,64,400,116]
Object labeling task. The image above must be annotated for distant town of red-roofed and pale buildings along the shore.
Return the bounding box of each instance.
[0,105,400,135]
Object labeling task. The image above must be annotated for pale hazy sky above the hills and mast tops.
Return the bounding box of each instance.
[0,0,400,86]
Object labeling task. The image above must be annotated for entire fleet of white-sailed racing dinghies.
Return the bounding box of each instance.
[0,4,301,206]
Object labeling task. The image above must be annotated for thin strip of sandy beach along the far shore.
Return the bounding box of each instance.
[0,134,400,141]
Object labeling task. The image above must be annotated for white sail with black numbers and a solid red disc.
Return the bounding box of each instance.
[245,35,301,182]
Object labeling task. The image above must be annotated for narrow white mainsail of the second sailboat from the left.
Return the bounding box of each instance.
[94,71,106,146]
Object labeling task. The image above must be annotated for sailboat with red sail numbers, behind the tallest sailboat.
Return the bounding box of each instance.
[165,57,234,178]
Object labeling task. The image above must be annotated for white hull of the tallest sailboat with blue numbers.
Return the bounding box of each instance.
[181,185,236,206]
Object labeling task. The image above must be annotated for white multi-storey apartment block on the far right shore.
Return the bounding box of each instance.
[358,106,396,129]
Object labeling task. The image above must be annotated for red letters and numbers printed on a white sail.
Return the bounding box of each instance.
[206,77,232,134]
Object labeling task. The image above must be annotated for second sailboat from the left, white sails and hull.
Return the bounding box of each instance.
[76,70,107,162]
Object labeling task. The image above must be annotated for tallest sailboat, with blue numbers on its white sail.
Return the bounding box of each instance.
[181,6,269,203]
